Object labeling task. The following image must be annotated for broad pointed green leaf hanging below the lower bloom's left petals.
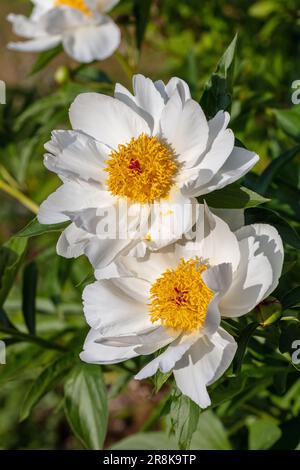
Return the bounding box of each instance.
[65,363,108,450]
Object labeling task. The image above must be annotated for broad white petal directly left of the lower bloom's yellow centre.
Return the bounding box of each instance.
[83,279,153,336]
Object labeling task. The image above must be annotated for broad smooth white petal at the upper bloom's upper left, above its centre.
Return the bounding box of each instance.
[70,93,150,149]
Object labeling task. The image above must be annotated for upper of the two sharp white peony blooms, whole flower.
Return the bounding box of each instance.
[39,75,258,266]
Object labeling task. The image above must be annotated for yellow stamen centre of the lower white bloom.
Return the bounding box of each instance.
[149,259,214,332]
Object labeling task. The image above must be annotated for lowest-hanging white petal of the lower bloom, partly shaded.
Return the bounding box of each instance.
[173,328,237,408]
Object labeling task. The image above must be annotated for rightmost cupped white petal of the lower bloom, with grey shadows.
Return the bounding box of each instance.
[220,224,283,317]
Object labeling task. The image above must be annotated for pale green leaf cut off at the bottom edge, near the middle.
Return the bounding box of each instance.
[110,432,178,450]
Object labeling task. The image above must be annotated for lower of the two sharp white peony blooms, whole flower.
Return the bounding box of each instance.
[81,206,283,408]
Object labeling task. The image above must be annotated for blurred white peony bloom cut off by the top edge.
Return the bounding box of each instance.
[8,0,120,63]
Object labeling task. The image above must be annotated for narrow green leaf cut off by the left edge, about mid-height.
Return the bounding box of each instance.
[0,238,27,307]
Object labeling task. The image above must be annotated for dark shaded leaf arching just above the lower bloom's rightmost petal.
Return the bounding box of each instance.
[245,208,300,250]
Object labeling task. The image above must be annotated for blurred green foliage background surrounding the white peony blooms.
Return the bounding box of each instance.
[0,0,300,449]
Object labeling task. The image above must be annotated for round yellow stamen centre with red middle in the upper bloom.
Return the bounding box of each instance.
[105,134,177,204]
